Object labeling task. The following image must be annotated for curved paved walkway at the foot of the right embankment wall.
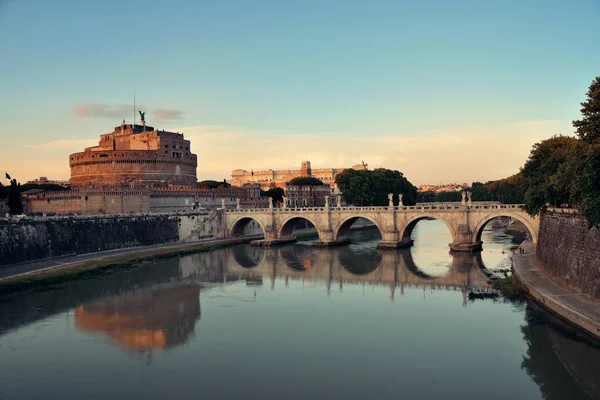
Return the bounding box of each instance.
[513,241,600,339]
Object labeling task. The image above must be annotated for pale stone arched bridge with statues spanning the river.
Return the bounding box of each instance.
[222,202,540,252]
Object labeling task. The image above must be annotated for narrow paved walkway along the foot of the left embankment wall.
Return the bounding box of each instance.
[0,238,251,282]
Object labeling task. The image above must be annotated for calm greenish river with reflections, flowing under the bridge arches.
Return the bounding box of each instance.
[0,221,600,400]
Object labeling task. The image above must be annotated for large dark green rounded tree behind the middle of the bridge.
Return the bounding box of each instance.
[335,168,417,206]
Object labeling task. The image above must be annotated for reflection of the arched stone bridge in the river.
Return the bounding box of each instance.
[227,241,490,305]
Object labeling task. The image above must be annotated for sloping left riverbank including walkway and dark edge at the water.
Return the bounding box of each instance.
[0,237,259,295]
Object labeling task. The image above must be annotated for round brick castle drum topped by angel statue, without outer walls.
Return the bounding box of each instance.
[69,120,198,189]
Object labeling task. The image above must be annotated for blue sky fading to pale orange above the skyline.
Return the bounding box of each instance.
[0,0,600,185]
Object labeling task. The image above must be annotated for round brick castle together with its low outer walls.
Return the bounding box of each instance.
[25,112,267,215]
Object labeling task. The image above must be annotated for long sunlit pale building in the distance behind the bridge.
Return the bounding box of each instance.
[229,161,367,194]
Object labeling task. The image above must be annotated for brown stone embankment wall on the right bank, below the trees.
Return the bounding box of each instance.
[537,210,600,299]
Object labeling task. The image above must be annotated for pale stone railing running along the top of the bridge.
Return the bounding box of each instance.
[223,203,523,214]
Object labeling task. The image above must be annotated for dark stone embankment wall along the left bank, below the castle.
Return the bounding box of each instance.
[0,211,231,266]
